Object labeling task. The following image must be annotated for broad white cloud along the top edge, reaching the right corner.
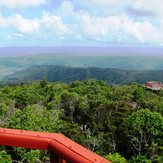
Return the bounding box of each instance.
[77,0,163,18]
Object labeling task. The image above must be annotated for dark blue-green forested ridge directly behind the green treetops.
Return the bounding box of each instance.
[2,66,163,85]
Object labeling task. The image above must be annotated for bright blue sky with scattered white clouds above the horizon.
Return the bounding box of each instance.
[0,0,163,47]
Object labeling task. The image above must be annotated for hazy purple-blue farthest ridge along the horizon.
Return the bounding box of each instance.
[0,46,163,57]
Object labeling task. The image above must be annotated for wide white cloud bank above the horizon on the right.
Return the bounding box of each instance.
[80,11,163,43]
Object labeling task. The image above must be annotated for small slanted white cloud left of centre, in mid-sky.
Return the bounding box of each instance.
[42,12,69,34]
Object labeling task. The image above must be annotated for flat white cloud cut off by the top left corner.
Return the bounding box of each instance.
[0,0,47,8]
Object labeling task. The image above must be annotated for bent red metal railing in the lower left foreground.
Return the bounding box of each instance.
[0,128,110,163]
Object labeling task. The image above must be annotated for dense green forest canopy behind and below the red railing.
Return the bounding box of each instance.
[0,79,163,163]
